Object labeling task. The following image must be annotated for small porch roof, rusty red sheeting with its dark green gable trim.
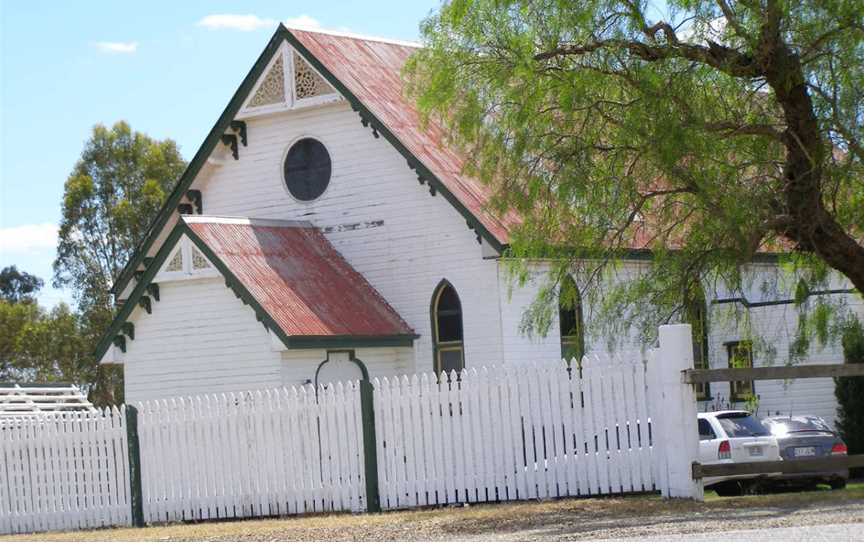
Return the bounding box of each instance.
[96,216,417,360]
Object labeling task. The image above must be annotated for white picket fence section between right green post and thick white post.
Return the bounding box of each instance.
[375,354,656,509]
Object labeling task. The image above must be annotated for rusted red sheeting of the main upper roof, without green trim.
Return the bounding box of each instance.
[289,29,519,245]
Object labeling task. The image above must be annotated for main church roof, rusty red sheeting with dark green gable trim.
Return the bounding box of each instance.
[111,25,517,295]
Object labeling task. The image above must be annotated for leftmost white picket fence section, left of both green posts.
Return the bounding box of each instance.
[0,407,130,533]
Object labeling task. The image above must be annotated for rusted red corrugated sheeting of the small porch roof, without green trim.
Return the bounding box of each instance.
[184,216,415,337]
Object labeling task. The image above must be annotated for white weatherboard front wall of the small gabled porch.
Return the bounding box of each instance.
[124,277,281,402]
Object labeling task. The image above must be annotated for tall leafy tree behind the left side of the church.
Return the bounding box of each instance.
[49,122,186,405]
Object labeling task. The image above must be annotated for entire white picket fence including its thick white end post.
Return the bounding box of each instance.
[0,326,702,533]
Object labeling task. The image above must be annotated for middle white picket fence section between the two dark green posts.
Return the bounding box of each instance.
[138,382,366,523]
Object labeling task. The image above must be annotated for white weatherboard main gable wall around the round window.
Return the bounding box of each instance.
[193,103,506,372]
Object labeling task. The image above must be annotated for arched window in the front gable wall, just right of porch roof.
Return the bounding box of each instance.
[432,280,465,374]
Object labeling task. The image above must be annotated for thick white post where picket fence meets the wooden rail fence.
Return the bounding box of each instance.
[648,324,704,500]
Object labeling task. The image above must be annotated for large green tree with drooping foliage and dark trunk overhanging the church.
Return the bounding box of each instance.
[406,0,864,340]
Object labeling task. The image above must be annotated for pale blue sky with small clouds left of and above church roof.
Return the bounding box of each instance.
[0,0,438,305]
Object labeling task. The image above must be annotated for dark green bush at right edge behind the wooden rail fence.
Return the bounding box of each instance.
[834,322,864,460]
